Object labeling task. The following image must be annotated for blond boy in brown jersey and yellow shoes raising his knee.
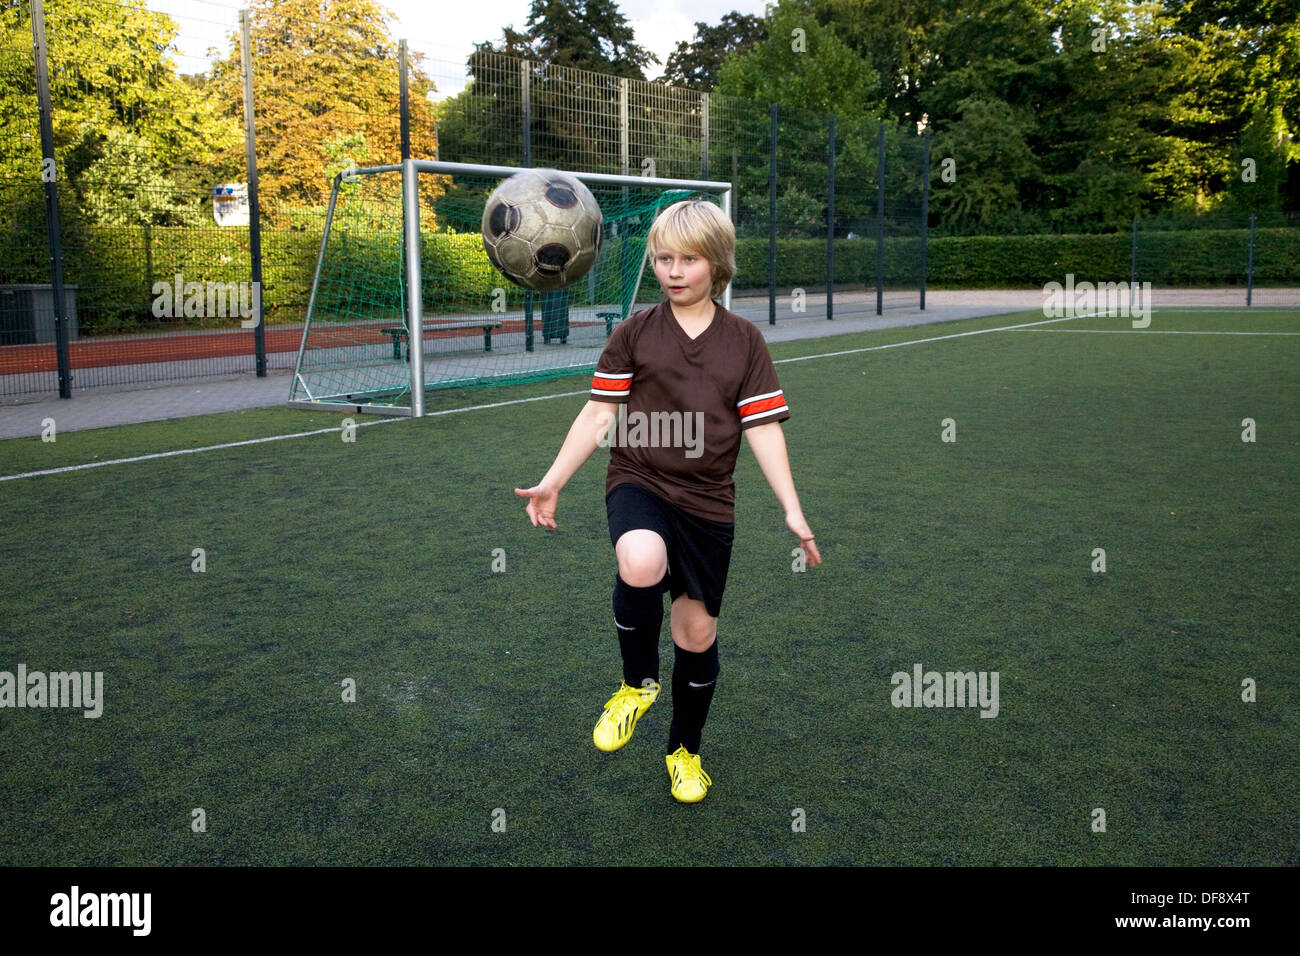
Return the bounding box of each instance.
[515,200,822,803]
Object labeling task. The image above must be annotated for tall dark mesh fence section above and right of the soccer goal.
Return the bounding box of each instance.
[434,52,930,321]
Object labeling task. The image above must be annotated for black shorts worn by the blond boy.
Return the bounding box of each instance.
[605,481,736,618]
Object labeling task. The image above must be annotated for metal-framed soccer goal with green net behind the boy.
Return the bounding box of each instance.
[289,160,731,418]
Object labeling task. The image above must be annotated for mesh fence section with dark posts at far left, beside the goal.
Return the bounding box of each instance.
[0,0,265,397]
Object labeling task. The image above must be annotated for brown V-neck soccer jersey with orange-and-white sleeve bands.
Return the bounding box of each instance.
[592,302,790,522]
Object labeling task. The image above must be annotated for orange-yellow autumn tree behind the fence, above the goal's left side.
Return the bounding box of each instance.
[212,0,437,221]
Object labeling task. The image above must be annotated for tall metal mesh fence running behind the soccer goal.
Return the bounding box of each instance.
[0,0,1300,397]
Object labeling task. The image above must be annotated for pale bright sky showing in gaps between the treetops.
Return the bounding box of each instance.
[146,0,766,99]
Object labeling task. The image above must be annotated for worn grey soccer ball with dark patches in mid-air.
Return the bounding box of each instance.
[482,169,603,291]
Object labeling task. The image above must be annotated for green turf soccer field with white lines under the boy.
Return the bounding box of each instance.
[0,310,1300,865]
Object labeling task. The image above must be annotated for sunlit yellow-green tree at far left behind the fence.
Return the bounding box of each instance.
[0,0,242,228]
